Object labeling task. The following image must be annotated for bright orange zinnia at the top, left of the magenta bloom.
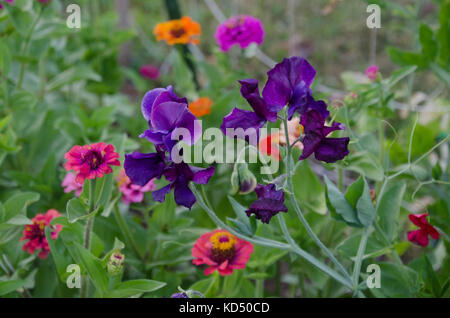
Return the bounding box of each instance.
[153,17,202,45]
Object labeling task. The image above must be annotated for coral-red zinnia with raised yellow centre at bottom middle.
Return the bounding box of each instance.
[192,229,253,276]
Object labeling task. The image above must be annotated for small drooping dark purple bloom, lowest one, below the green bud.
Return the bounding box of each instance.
[245,184,287,223]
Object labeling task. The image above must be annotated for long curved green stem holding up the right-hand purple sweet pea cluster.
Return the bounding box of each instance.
[283,114,352,282]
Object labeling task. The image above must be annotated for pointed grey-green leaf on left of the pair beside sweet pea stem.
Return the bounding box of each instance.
[324,176,362,227]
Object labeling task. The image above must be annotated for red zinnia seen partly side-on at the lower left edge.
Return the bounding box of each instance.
[20,209,62,259]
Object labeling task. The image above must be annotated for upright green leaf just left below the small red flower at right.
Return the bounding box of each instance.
[377,182,406,241]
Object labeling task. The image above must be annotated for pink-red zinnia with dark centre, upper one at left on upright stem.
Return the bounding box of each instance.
[64,142,120,184]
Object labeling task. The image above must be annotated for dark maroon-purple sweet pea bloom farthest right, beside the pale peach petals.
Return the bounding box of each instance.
[299,109,350,163]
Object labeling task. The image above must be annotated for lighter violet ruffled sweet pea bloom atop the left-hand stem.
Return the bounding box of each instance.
[140,86,201,153]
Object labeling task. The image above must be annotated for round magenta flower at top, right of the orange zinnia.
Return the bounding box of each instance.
[214,15,264,52]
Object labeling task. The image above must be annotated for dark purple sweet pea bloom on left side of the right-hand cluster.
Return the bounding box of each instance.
[220,79,277,138]
